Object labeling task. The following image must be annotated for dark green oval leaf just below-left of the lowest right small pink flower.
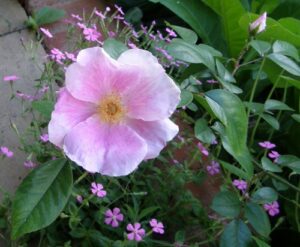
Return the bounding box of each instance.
[245,202,271,237]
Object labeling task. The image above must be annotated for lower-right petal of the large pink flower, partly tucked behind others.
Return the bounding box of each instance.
[128,119,179,159]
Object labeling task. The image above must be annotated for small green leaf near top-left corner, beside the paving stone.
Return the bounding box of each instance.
[34,7,65,26]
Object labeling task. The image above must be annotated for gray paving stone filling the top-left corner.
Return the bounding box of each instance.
[0,0,27,35]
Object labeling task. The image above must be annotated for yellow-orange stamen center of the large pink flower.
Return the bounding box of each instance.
[98,94,126,123]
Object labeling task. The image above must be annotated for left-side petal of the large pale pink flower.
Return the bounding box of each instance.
[48,89,96,147]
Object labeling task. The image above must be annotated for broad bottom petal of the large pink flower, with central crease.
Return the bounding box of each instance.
[64,115,147,176]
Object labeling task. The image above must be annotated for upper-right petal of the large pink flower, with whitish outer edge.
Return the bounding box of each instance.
[118,49,180,121]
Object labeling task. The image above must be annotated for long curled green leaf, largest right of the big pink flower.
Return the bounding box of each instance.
[205,89,253,177]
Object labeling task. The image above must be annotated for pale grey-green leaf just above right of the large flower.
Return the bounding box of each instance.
[167,39,215,71]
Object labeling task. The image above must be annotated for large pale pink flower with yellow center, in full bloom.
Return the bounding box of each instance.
[49,47,180,176]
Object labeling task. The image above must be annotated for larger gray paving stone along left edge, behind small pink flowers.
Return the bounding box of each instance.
[0,29,46,200]
